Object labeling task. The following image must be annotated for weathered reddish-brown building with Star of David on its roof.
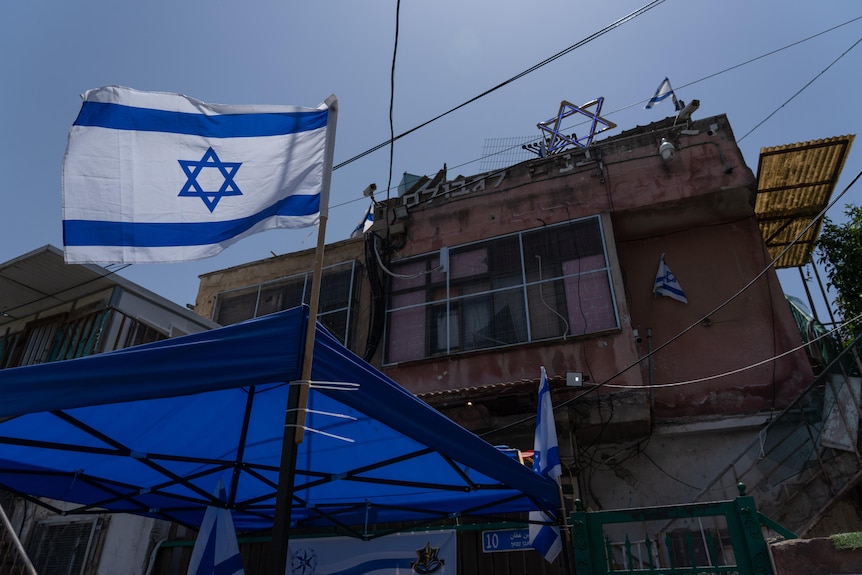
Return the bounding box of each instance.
[195,111,858,544]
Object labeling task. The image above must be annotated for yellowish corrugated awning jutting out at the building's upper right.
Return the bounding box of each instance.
[754,135,855,268]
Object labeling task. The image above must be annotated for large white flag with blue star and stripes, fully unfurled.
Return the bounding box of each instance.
[63,86,337,263]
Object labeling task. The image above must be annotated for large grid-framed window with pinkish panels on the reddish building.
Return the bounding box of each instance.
[384,217,619,364]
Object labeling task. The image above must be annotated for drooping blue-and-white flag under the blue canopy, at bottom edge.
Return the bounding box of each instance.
[187,479,244,575]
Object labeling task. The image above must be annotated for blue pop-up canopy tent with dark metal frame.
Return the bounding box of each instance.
[0,306,559,531]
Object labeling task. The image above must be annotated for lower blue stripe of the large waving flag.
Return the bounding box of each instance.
[63,194,320,248]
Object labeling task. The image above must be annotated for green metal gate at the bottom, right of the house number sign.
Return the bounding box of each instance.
[570,484,796,575]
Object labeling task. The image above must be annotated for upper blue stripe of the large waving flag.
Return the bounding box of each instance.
[75,102,328,138]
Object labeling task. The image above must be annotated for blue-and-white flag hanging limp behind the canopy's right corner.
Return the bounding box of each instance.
[530,367,563,563]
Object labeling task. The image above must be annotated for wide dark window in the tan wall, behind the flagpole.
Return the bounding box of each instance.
[213,261,356,345]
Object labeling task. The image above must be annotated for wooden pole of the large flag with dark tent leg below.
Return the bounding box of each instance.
[268,94,338,575]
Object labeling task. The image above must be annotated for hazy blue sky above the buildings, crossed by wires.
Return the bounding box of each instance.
[0,0,862,320]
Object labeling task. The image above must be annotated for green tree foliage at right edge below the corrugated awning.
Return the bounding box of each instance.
[817,205,862,344]
